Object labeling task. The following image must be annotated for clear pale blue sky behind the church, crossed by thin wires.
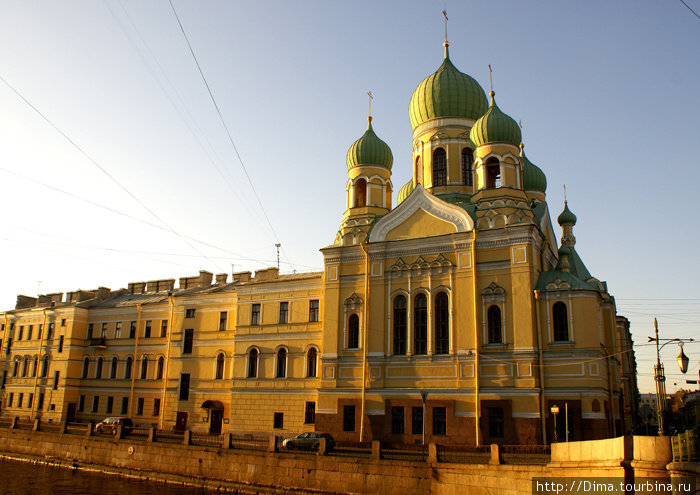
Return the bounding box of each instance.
[0,0,700,392]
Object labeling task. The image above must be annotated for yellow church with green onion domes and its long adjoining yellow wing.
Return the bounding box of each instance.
[0,36,636,444]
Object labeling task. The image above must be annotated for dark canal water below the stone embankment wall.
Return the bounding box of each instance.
[0,459,216,495]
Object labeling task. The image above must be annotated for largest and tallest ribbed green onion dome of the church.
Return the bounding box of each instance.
[408,43,488,129]
